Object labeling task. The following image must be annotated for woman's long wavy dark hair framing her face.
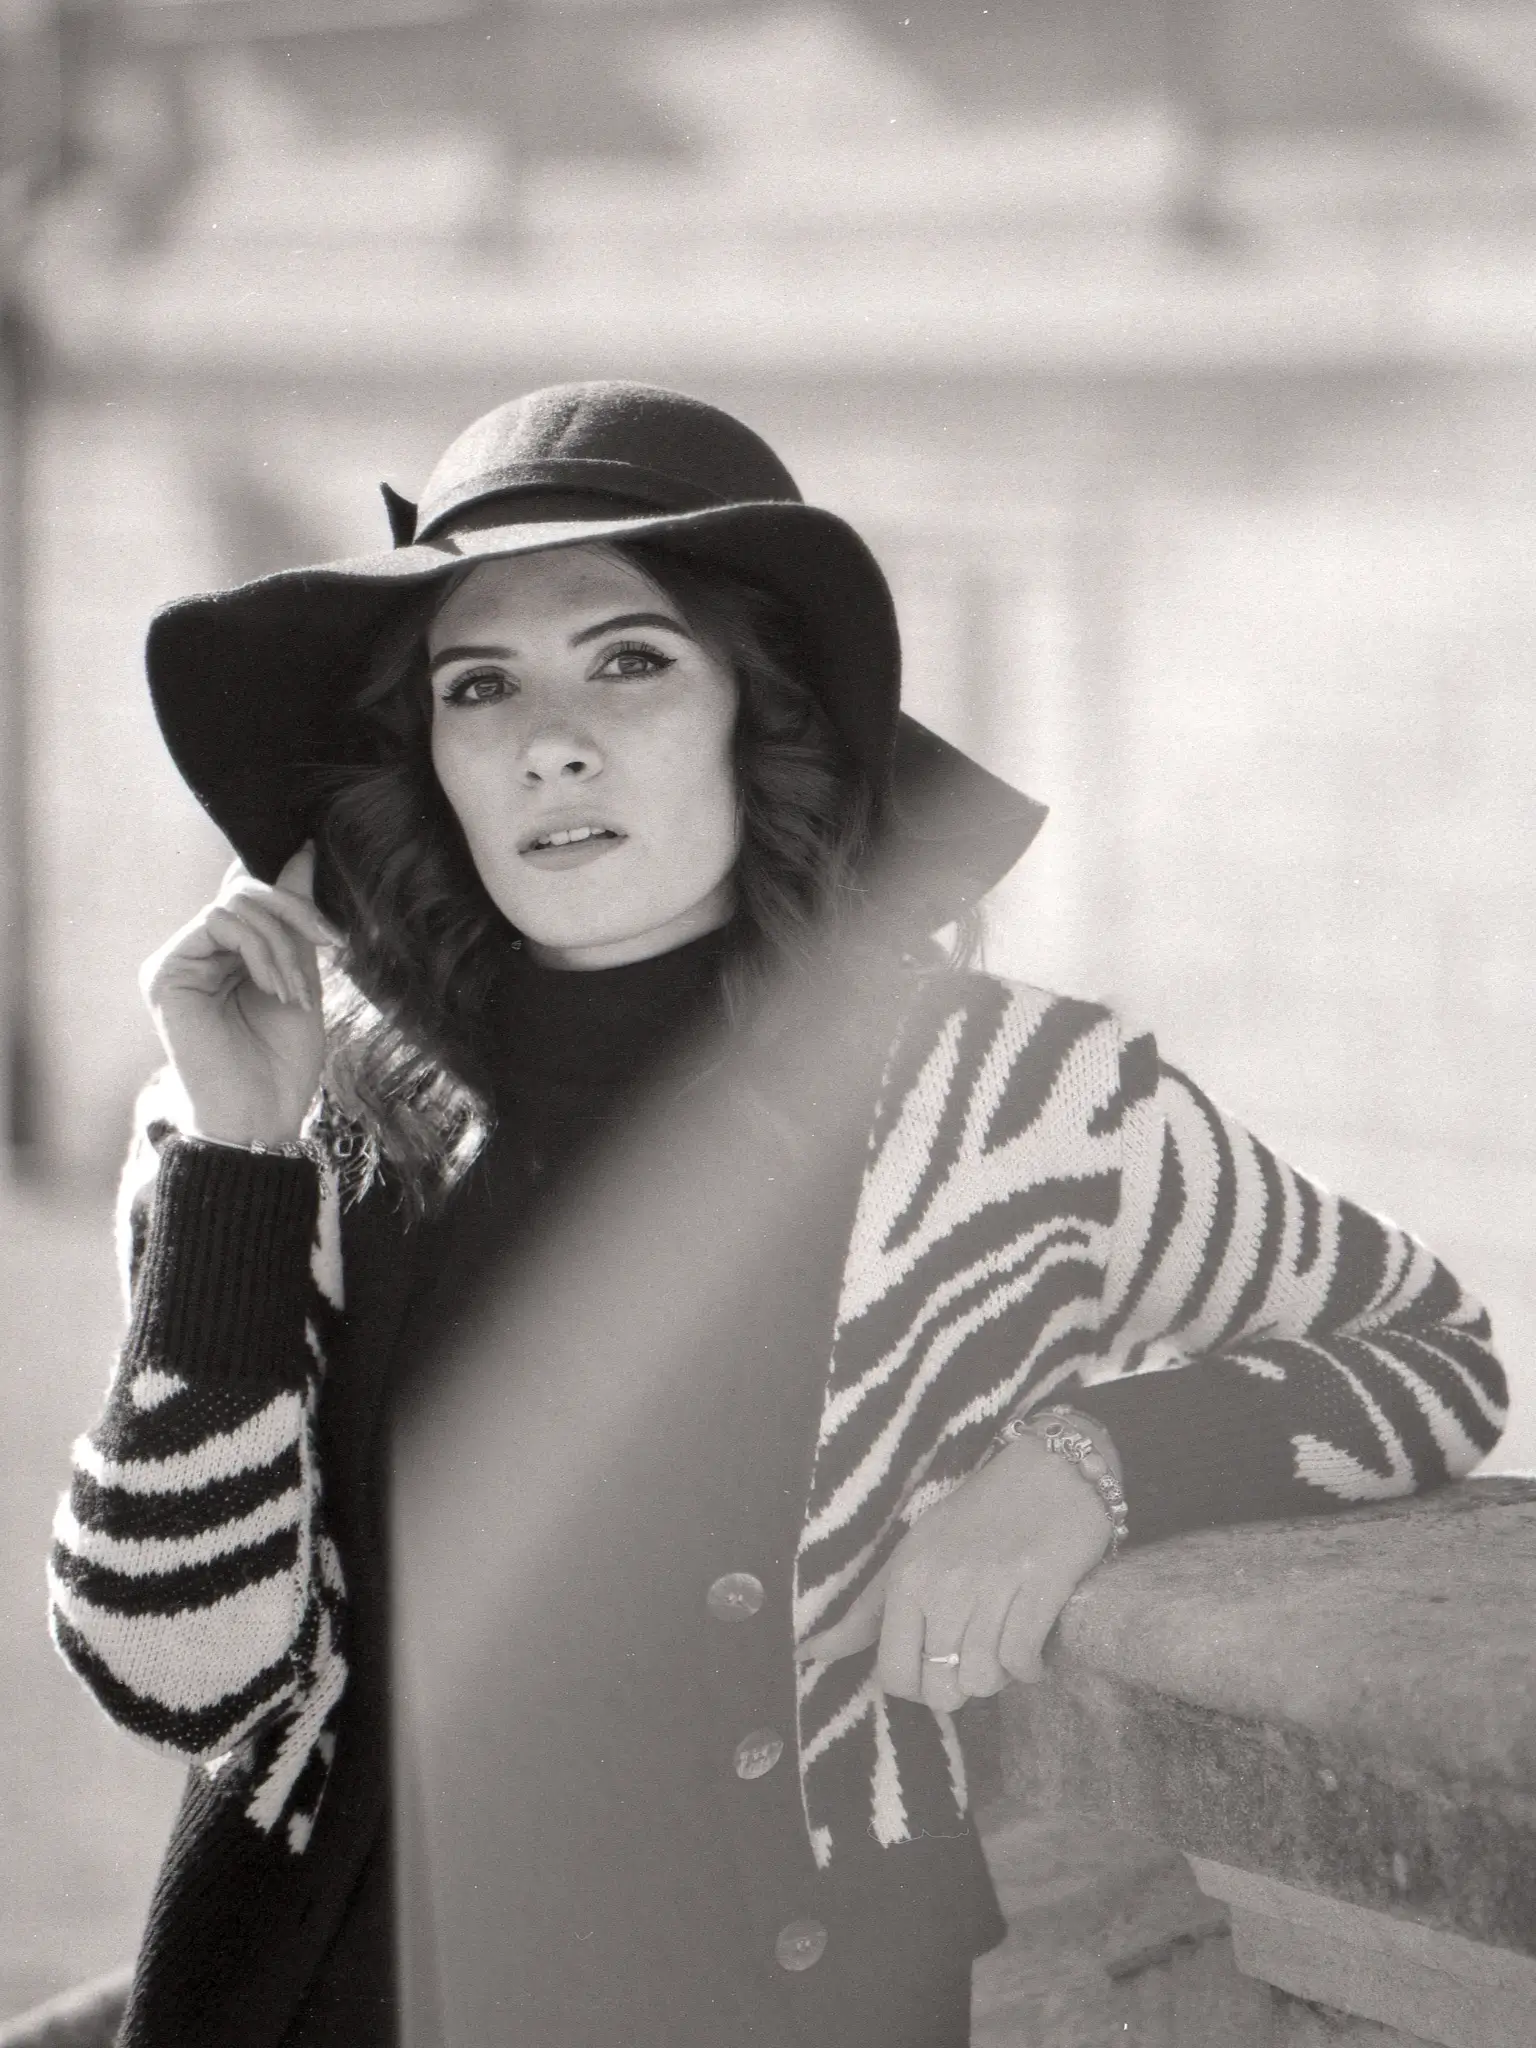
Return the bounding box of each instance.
[315,543,897,1212]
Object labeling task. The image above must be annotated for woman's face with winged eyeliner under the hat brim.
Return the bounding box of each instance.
[426,547,737,969]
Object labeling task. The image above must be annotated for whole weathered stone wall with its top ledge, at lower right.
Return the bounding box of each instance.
[973,1481,1536,2048]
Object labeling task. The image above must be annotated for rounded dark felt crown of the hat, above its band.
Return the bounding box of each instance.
[416,381,801,539]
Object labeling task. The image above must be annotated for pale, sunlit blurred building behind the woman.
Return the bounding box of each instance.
[6,0,1536,1376]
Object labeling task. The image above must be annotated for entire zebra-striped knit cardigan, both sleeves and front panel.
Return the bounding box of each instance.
[51,975,1505,1900]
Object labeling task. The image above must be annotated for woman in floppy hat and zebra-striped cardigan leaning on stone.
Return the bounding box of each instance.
[53,385,1503,2048]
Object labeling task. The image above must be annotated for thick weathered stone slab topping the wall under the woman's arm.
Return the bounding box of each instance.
[999,1479,1536,1956]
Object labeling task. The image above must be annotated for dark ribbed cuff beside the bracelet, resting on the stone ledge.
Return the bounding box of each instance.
[1061,1360,1302,1544]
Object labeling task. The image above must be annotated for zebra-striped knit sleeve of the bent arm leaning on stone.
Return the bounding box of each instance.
[1081,1038,1507,1540]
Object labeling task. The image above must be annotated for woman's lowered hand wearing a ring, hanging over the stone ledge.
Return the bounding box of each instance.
[795,1432,1118,1714]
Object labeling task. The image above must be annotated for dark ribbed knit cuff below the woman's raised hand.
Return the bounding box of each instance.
[125,1139,319,1382]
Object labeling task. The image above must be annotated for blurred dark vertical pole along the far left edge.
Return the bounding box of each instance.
[0,0,61,1174]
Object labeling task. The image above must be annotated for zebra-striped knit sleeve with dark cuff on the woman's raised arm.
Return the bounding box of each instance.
[49,1124,344,1761]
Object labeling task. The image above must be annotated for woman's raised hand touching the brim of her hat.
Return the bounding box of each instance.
[139,846,338,1145]
